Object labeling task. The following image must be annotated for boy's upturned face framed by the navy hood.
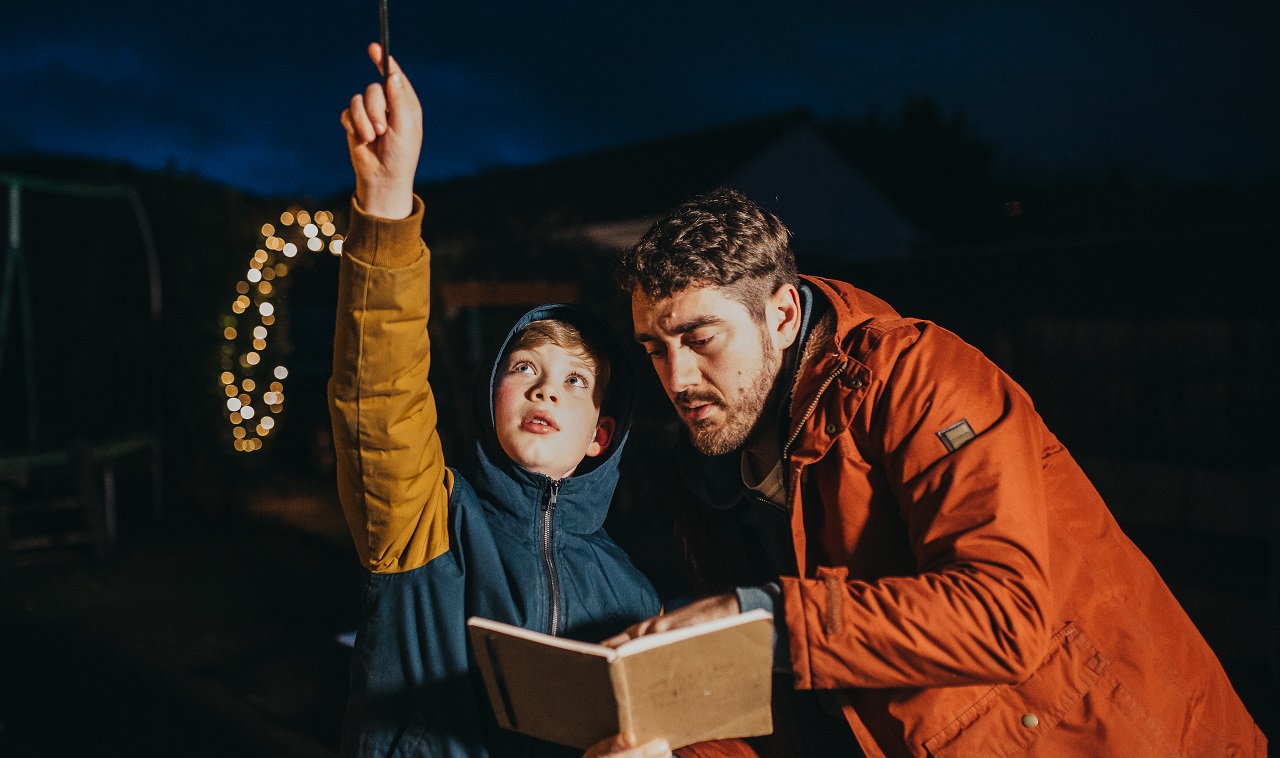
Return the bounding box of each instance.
[494,343,613,479]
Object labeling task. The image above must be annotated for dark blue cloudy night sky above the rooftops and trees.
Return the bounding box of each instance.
[0,0,1280,197]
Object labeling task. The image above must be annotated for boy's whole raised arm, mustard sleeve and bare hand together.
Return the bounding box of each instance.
[329,44,452,572]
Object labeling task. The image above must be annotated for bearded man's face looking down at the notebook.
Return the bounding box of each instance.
[631,286,799,456]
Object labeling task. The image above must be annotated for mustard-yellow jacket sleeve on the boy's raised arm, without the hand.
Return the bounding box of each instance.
[329,197,453,572]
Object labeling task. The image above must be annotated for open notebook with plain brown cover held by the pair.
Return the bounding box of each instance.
[467,611,773,749]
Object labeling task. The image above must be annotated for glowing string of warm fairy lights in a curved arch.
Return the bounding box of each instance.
[218,207,343,453]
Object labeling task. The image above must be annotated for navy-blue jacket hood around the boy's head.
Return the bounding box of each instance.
[467,303,636,534]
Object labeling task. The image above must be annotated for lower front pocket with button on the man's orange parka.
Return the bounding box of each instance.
[924,622,1110,758]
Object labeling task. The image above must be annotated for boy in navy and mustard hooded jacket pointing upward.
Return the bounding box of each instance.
[329,45,659,757]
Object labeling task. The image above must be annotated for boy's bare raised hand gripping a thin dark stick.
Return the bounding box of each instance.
[342,42,422,219]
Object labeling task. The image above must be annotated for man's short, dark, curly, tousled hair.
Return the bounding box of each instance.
[618,187,799,321]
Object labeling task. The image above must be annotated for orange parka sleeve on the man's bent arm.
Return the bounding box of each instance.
[782,323,1052,689]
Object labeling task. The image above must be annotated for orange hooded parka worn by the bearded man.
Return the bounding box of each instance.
[696,278,1266,758]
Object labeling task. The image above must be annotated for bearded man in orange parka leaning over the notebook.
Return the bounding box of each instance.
[613,190,1266,757]
